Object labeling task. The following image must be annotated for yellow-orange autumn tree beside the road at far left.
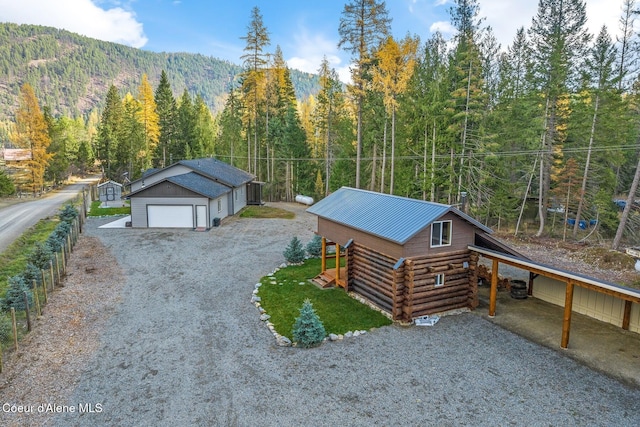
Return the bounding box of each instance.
[10,83,53,193]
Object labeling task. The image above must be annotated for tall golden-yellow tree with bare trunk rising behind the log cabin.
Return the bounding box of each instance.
[373,36,418,194]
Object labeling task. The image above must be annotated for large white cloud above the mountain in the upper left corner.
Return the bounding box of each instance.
[0,0,147,48]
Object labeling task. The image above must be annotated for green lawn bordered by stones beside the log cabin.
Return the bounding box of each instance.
[258,258,392,339]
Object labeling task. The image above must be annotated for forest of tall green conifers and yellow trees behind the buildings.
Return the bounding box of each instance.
[0,0,640,247]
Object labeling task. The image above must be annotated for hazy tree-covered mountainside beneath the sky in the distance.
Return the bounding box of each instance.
[0,23,318,120]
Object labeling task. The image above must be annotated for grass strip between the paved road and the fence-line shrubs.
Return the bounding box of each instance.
[0,218,60,296]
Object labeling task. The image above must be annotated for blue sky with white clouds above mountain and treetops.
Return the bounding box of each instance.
[0,0,623,83]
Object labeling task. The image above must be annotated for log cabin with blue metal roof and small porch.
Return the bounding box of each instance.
[307,187,493,321]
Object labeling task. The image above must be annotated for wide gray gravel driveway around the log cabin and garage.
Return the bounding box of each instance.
[48,204,640,426]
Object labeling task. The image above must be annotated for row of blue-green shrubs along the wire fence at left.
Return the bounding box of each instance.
[0,192,90,372]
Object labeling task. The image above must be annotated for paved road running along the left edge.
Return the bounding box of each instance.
[0,177,96,253]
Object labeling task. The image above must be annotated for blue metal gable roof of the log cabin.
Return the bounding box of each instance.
[307,187,491,245]
